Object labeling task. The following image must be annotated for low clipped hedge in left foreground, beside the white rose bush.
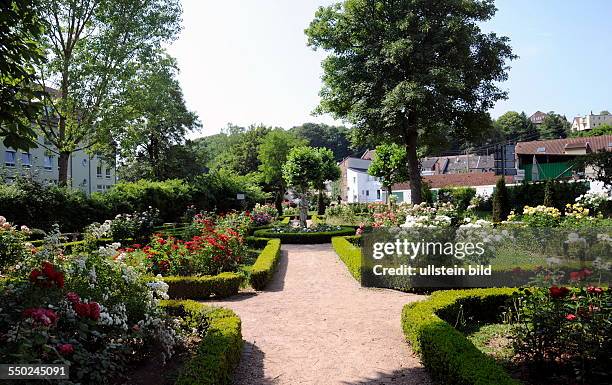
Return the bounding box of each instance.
[161,300,243,385]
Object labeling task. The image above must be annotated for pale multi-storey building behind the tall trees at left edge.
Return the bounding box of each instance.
[0,137,117,195]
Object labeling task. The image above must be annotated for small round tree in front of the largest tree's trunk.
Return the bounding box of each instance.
[368,143,408,205]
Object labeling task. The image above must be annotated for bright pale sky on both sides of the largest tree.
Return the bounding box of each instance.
[169,0,612,137]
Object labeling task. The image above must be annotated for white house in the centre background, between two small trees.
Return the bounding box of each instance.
[332,157,383,203]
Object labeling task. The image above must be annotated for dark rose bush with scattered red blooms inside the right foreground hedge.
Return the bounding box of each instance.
[513,286,612,383]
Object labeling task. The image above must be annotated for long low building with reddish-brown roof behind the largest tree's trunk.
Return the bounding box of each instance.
[392,171,514,203]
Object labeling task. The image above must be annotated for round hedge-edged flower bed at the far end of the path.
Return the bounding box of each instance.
[253,225,355,244]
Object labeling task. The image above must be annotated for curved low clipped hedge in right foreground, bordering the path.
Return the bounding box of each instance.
[402,288,520,385]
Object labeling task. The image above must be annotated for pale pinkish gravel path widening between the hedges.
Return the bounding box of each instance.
[208,244,430,385]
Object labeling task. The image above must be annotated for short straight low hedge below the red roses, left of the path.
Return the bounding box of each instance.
[162,273,244,299]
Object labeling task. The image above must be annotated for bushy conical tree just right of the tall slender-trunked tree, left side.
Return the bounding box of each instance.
[106,51,200,180]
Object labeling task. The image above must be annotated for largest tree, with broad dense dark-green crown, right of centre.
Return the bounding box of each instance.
[305,0,515,203]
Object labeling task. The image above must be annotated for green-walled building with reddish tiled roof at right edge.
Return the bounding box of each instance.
[515,135,612,181]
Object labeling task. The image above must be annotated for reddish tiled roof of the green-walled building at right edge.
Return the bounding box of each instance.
[515,135,612,155]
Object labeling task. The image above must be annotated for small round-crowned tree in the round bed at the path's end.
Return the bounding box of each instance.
[283,146,321,227]
